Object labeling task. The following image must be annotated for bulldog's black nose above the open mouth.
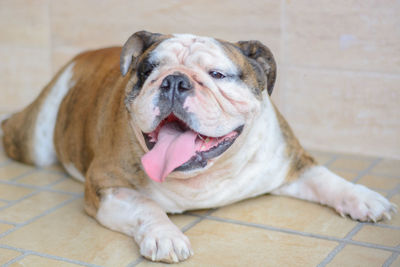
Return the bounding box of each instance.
[160,74,192,97]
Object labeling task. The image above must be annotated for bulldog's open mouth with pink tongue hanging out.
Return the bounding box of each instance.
[142,113,243,182]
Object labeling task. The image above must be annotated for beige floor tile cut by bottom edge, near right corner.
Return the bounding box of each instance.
[328,245,395,267]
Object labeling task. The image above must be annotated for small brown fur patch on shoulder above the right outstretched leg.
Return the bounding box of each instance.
[274,105,317,182]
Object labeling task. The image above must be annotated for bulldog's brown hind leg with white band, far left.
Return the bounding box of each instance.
[1,63,74,166]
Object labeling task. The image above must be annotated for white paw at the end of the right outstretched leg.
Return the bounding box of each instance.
[335,184,396,222]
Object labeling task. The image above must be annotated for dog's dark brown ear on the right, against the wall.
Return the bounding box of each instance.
[236,41,276,95]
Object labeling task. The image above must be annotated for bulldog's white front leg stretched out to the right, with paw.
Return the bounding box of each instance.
[272,166,395,222]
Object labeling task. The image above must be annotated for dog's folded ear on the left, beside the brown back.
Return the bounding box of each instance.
[120,31,162,76]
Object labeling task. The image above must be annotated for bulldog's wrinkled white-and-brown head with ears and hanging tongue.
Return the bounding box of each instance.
[121,31,276,181]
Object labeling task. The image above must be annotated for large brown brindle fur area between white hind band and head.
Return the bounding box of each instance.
[51,47,147,216]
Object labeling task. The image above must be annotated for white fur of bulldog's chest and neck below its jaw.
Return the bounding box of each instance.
[139,92,290,213]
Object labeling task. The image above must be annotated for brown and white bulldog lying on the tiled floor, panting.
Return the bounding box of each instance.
[2,31,395,262]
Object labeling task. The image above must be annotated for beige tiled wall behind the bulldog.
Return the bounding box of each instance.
[0,0,400,158]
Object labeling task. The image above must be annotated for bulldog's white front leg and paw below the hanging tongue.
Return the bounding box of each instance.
[96,188,193,262]
